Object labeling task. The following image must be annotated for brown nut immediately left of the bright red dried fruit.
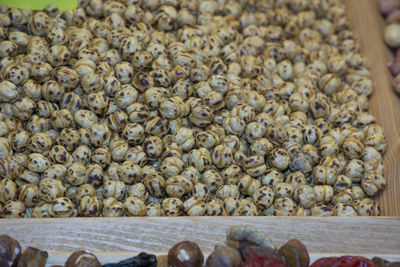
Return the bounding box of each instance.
[278,239,310,267]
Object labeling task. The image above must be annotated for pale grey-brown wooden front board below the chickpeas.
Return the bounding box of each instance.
[0,217,400,264]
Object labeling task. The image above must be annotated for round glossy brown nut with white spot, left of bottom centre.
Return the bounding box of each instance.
[168,241,204,267]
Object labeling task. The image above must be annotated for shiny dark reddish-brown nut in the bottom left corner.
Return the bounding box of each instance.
[0,235,21,267]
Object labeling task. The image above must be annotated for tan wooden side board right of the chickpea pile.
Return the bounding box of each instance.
[346,0,400,216]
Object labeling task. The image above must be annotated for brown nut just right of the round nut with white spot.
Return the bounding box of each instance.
[206,247,242,267]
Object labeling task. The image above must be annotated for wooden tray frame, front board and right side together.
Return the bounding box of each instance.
[0,0,400,265]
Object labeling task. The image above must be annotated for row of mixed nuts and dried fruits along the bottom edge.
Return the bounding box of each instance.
[0,225,400,267]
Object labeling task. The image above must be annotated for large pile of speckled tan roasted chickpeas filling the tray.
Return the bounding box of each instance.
[0,0,386,218]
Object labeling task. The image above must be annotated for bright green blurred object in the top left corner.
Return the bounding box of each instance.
[0,0,78,10]
